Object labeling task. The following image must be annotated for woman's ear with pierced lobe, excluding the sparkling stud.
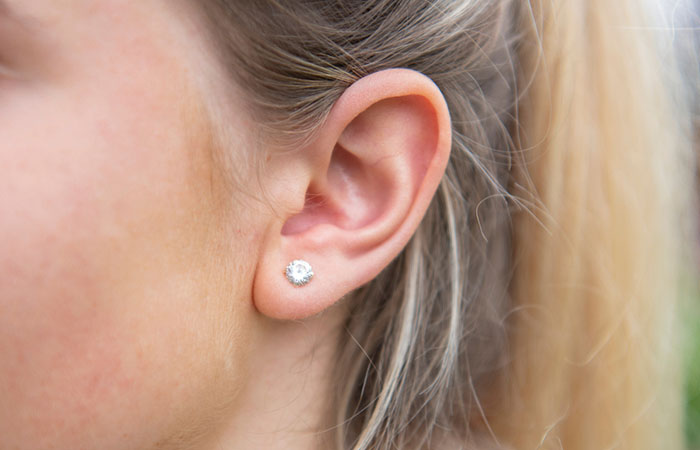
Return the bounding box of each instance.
[253,69,451,319]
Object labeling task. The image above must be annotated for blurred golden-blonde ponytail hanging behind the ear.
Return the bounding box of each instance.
[493,0,695,449]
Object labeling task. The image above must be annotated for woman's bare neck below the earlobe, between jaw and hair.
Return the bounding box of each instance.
[211,307,345,450]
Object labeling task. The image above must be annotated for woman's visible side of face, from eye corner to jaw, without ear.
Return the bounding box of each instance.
[0,0,258,449]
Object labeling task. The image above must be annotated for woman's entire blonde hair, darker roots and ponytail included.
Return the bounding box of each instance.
[193,0,693,450]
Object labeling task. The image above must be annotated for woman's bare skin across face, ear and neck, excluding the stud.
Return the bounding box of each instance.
[0,0,449,450]
